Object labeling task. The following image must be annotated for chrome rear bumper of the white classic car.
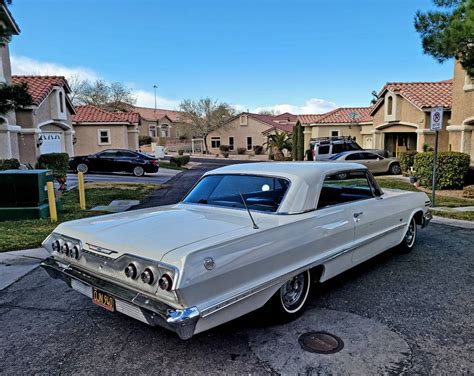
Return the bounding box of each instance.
[41,257,200,339]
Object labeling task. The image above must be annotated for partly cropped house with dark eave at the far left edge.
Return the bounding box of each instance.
[0,2,20,159]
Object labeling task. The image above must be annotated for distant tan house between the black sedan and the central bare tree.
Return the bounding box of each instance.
[130,106,193,143]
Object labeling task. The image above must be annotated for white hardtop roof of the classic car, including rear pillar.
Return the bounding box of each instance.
[205,161,367,213]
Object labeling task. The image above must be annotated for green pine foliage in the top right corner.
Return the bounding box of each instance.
[415,0,474,77]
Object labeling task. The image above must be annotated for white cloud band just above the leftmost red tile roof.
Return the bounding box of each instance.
[11,55,100,80]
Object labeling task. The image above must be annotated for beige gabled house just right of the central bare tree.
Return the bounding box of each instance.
[207,112,297,154]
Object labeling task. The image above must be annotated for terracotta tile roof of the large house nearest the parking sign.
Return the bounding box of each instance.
[372,80,453,113]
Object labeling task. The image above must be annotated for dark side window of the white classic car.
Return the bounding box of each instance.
[318,171,374,209]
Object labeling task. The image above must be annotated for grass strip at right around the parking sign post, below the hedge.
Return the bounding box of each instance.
[376,178,474,221]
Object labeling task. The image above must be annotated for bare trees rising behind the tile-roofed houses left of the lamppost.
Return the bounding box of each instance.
[71,77,136,111]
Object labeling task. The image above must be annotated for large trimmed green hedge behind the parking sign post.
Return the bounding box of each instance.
[413,151,470,189]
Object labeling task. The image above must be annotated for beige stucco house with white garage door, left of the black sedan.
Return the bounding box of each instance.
[12,76,75,164]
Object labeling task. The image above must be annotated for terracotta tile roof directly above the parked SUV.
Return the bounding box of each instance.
[298,107,372,124]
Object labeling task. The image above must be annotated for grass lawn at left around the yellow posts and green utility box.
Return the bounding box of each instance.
[0,183,159,252]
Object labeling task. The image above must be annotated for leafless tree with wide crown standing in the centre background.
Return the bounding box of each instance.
[179,98,235,153]
